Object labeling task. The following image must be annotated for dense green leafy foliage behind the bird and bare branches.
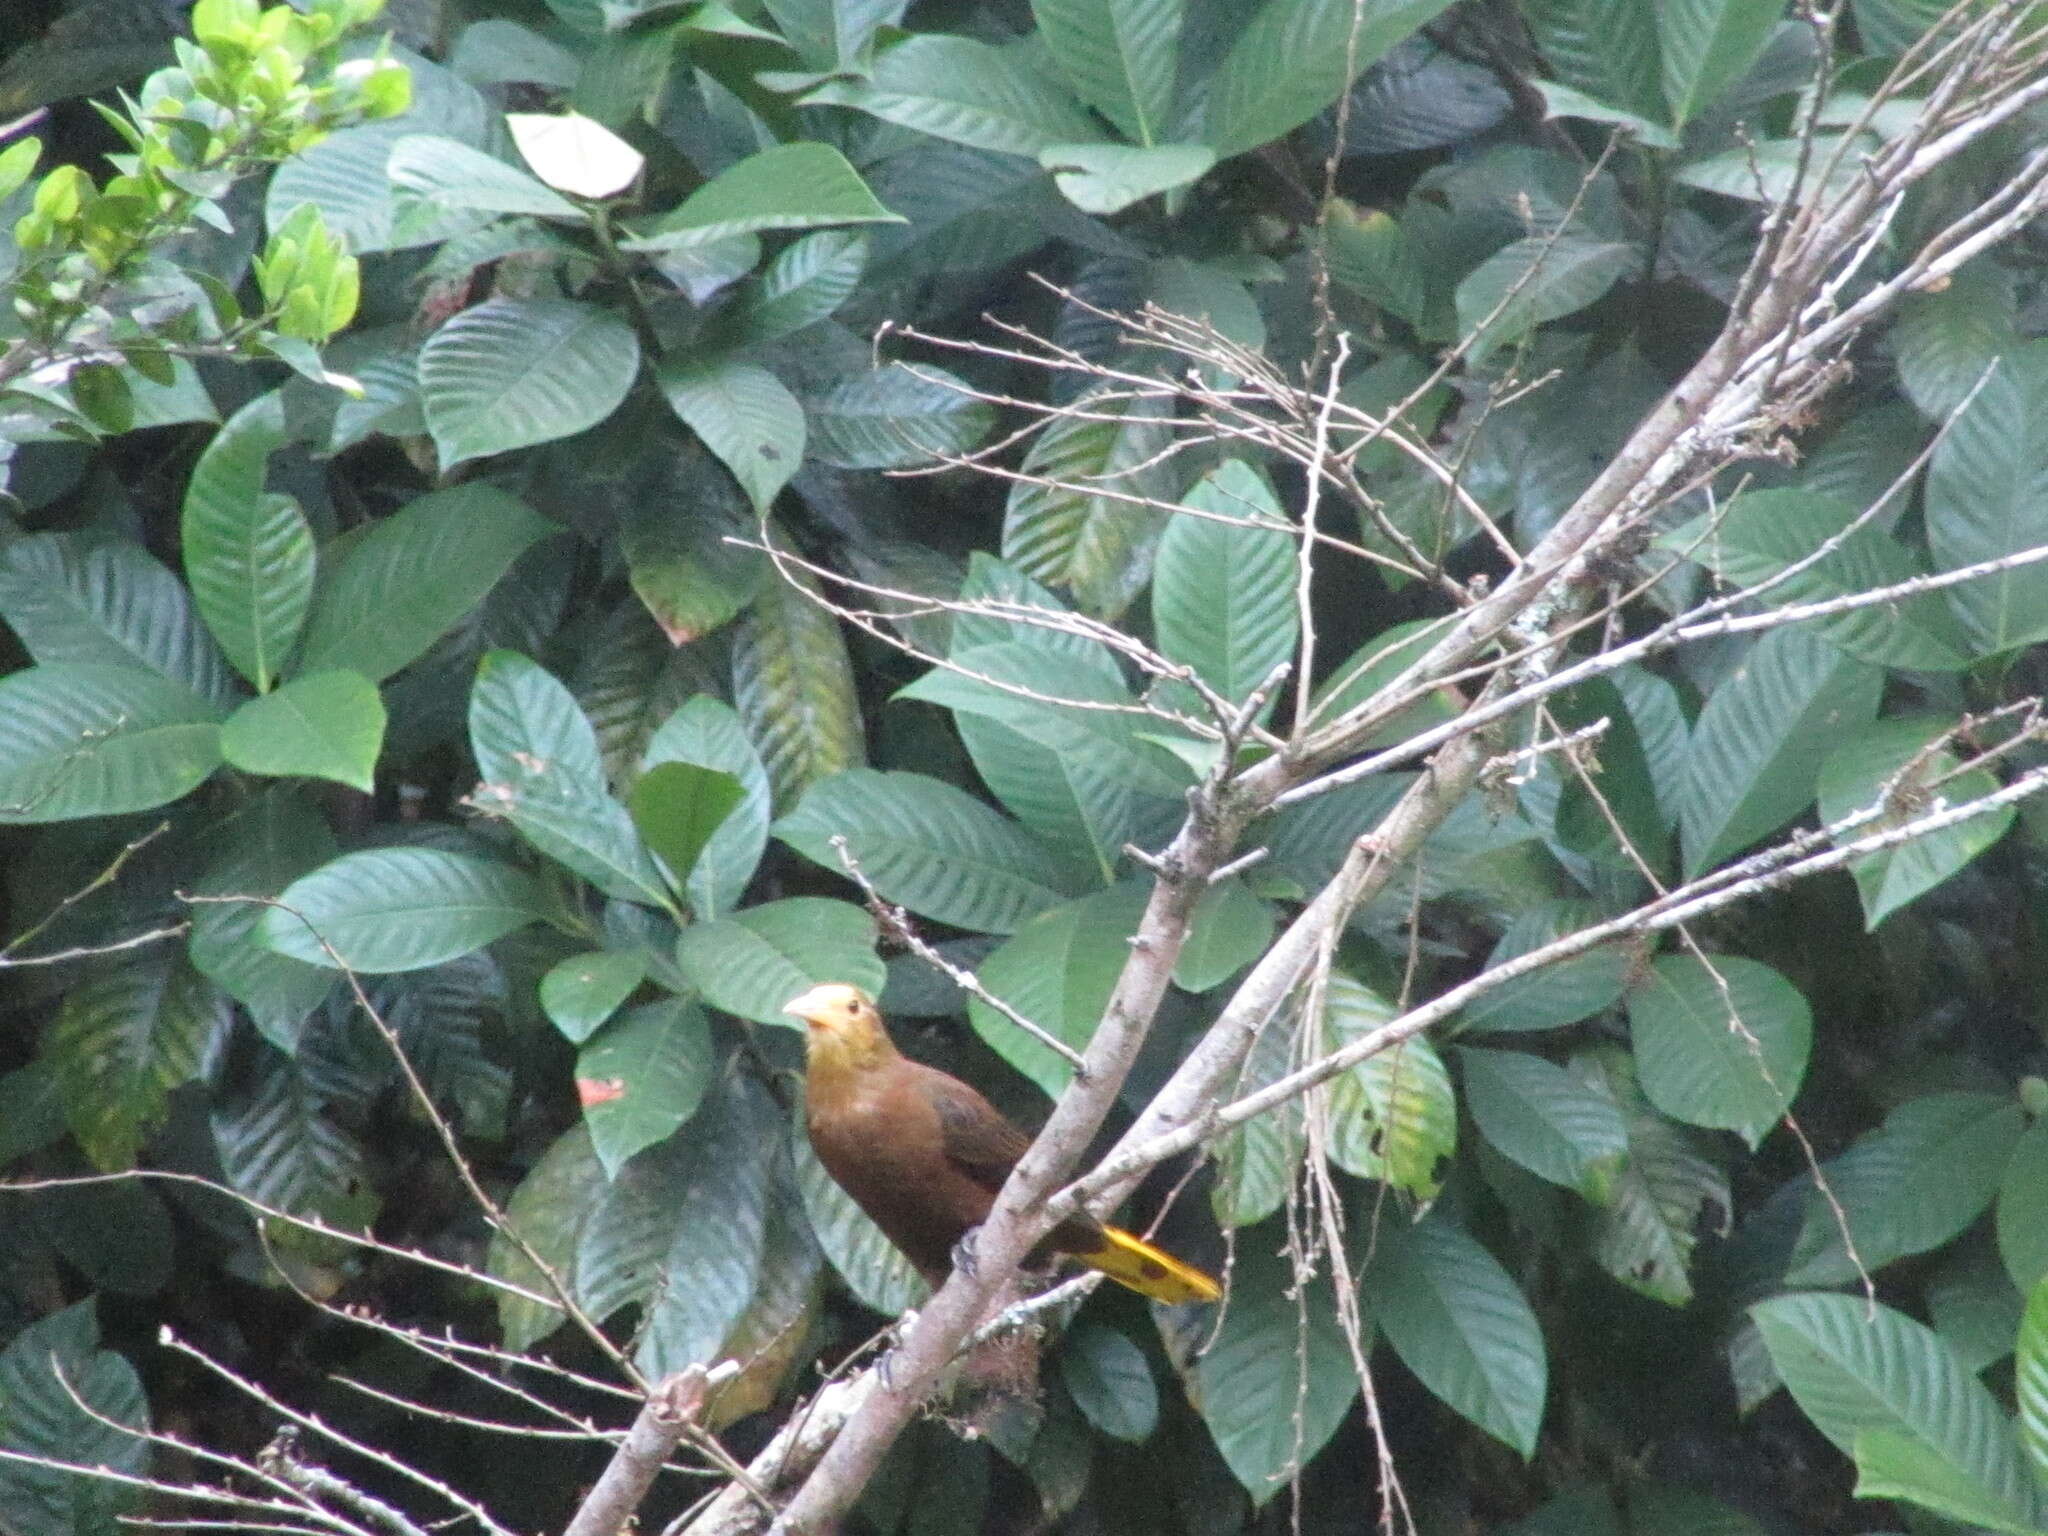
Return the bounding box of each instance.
[0,0,2048,1536]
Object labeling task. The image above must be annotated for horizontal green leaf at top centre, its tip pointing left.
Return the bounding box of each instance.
[805,33,1102,156]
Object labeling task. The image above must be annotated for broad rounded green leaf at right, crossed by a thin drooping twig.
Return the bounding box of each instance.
[1628,954,1812,1147]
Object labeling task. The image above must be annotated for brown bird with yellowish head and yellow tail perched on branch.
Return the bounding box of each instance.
[782,981,1223,1305]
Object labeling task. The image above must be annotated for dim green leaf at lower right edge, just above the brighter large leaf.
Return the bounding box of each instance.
[1784,1094,2021,1286]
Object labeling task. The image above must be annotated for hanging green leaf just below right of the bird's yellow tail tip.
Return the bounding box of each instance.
[1190,1227,1358,1503]
